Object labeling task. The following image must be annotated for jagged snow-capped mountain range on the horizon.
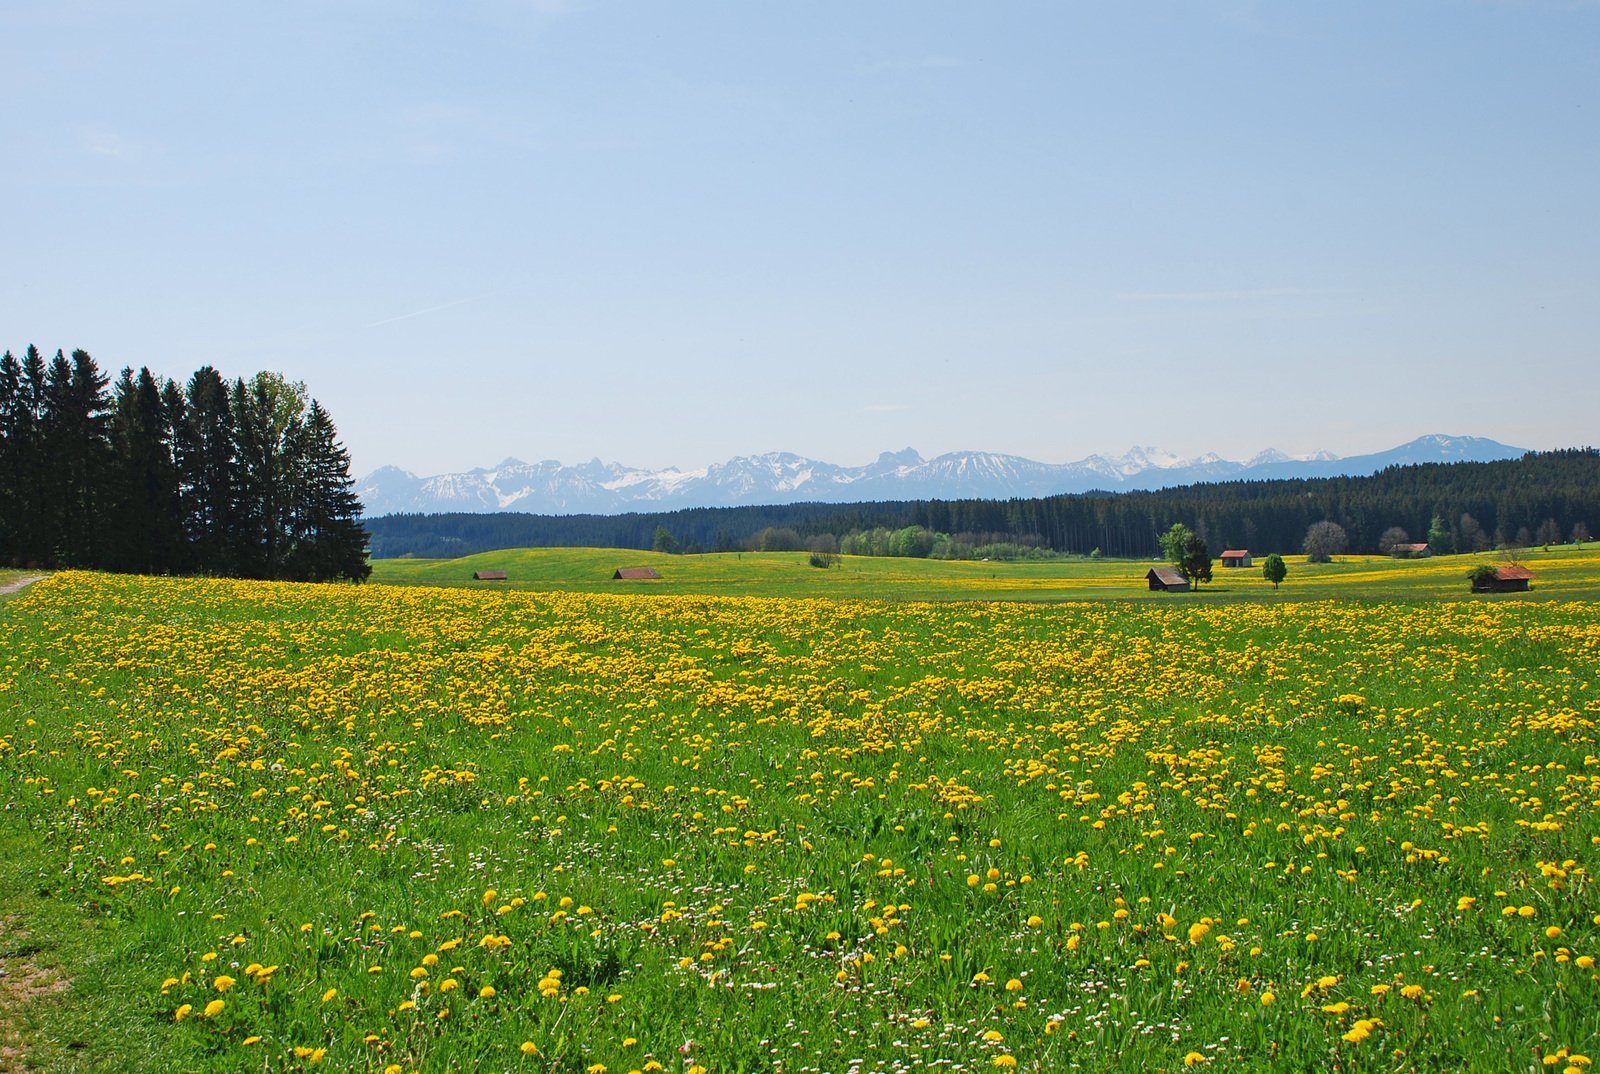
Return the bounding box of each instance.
[357,434,1525,517]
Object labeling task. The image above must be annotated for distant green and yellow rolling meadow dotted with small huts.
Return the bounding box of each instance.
[373,544,1600,603]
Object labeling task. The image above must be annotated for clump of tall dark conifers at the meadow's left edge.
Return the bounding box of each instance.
[0,346,371,581]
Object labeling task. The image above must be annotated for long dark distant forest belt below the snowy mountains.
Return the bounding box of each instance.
[366,448,1600,557]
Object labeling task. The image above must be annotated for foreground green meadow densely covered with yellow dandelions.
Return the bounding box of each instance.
[0,573,1600,1074]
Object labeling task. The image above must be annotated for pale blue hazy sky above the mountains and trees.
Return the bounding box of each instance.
[0,0,1600,474]
